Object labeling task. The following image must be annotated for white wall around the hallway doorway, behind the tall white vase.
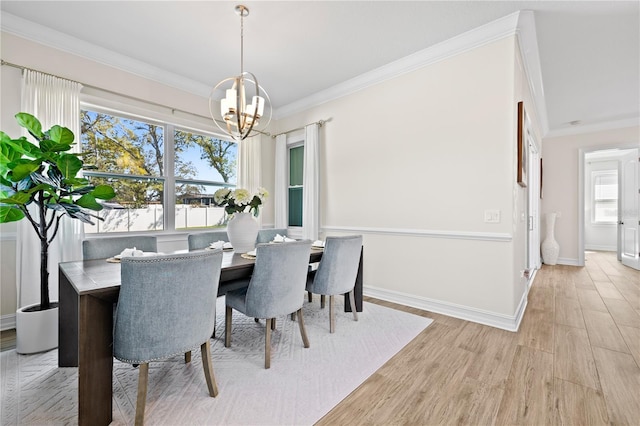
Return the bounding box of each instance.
[542,126,640,265]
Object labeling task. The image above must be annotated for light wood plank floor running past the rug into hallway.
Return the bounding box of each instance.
[316,252,640,426]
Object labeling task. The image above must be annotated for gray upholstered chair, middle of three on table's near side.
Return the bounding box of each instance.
[224,240,311,368]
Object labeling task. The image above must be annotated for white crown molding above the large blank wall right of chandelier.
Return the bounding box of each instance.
[273,12,524,119]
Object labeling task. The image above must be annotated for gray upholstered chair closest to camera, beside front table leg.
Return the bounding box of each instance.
[113,250,222,425]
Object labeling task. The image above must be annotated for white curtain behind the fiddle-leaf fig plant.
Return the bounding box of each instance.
[16,70,84,308]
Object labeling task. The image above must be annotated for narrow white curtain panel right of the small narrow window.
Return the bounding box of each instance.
[302,123,320,241]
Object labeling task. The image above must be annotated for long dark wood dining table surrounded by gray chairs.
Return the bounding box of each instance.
[58,248,363,425]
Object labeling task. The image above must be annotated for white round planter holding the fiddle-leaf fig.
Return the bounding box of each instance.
[16,302,58,354]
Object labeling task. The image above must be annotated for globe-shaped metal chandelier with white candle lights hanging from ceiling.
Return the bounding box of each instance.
[209,4,271,141]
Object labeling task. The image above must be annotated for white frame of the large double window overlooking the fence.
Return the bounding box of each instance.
[77,100,237,238]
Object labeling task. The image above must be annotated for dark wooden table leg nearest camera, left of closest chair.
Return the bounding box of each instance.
[78,295,113,426]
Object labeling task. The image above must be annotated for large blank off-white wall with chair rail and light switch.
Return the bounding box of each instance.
[277,37,535,330]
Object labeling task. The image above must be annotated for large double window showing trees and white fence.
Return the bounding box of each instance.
[81,106,237,233]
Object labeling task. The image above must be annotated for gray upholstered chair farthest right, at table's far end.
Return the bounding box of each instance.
[307,235,362,333]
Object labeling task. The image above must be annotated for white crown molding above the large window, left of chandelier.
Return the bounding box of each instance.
[0,12,211,97]
